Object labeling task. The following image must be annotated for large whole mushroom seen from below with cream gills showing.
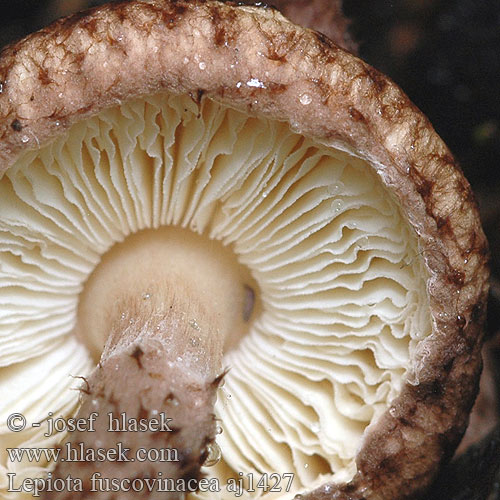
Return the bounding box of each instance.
[0,0,487,500]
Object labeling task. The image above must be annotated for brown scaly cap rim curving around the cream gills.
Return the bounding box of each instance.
[0,0,488,500]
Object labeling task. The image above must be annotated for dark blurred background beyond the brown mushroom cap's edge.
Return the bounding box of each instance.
[0,0,500,500]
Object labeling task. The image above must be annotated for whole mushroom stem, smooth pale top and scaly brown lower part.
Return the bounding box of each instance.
[45,230,245,499]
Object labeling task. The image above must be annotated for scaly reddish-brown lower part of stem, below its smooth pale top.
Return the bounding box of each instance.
[45,336,223,499]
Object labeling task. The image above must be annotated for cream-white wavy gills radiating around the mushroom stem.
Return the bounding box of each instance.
[0,93,431,499]
